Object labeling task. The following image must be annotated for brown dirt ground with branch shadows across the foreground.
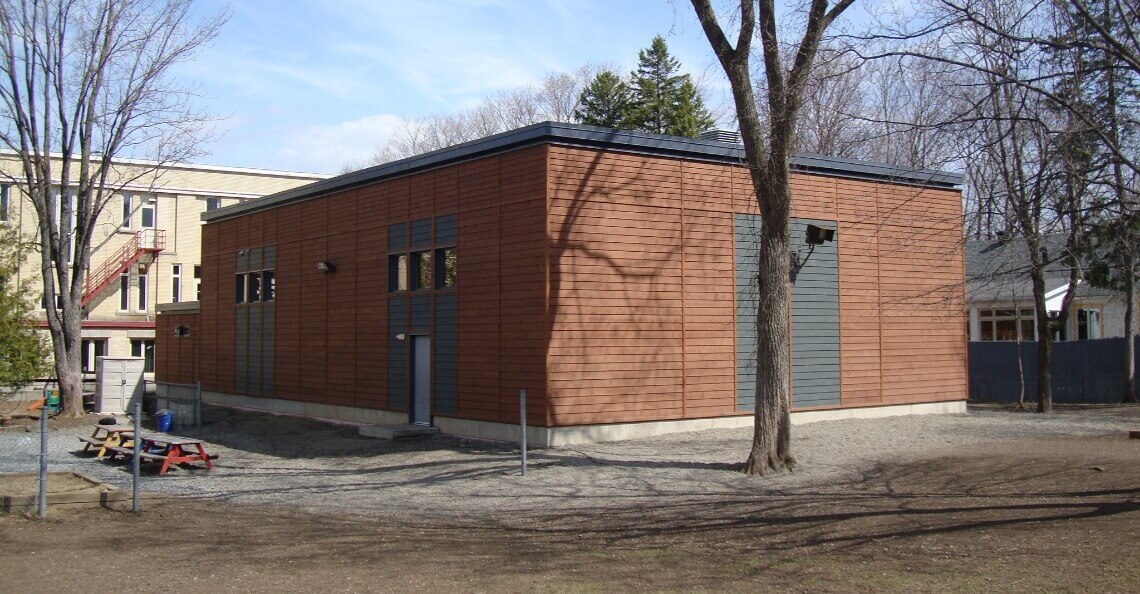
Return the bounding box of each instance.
[0,410,1140,593]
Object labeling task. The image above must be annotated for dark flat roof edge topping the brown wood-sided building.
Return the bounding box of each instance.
[202,122,963,221]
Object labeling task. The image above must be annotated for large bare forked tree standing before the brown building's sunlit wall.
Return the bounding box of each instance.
[692,0,854,474]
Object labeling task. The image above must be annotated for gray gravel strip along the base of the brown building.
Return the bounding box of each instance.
[0,406,1140,515]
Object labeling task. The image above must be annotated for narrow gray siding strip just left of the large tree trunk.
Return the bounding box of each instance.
[733,213,760,410]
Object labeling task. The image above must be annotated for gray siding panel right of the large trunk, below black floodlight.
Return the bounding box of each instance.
[789,219,841,407]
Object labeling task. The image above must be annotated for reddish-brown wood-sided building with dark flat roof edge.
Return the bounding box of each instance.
[157,123,967,437]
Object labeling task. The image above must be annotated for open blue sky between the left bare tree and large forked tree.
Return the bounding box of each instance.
[177,0,724,173]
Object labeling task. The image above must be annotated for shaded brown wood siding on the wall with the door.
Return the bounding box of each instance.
[193,147,546,424]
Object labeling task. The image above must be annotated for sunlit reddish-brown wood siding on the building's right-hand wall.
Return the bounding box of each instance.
[547,147,966,425]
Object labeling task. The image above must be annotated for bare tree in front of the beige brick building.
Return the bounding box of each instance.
[0,0,225,416]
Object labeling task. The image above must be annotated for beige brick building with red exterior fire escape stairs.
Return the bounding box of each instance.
[0,153,327,379]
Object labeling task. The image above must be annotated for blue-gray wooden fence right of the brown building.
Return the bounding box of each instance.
[969,336,1140,404]
